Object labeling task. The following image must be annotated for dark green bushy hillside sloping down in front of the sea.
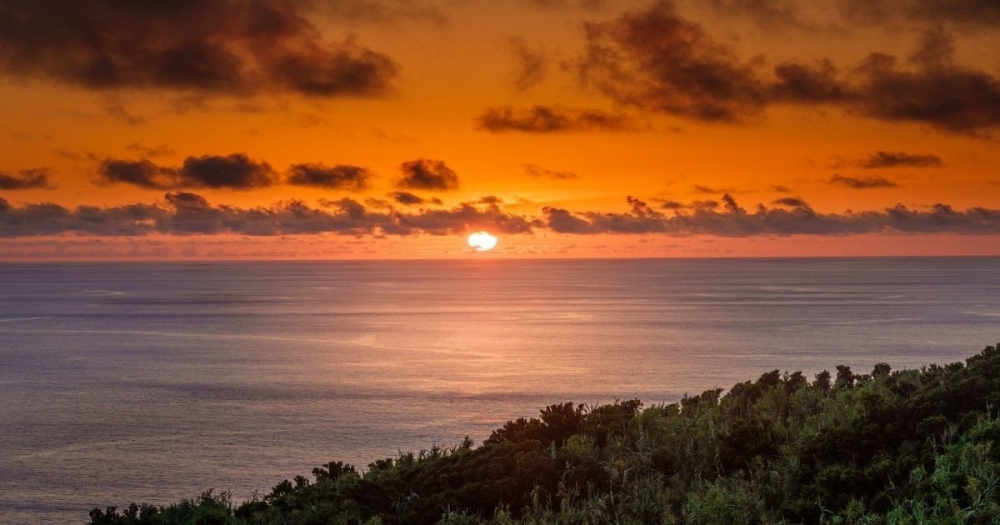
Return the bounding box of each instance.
[90,345,1000,525]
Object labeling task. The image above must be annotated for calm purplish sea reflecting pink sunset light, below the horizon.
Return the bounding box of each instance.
[0,258,1000,523]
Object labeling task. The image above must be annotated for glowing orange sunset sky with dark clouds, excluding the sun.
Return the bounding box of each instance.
[0,0,1000,260]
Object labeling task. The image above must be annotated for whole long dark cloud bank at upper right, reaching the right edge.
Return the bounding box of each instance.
[576,6,1000,136]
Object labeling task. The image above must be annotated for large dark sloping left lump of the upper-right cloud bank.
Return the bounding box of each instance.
[580,2,768,122]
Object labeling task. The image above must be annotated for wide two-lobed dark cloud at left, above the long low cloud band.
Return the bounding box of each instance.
[98,153,274,190]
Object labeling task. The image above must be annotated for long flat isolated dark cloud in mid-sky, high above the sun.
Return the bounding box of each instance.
[477,106,635,133]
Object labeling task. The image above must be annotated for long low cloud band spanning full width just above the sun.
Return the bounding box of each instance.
[0,192,1000,238]
